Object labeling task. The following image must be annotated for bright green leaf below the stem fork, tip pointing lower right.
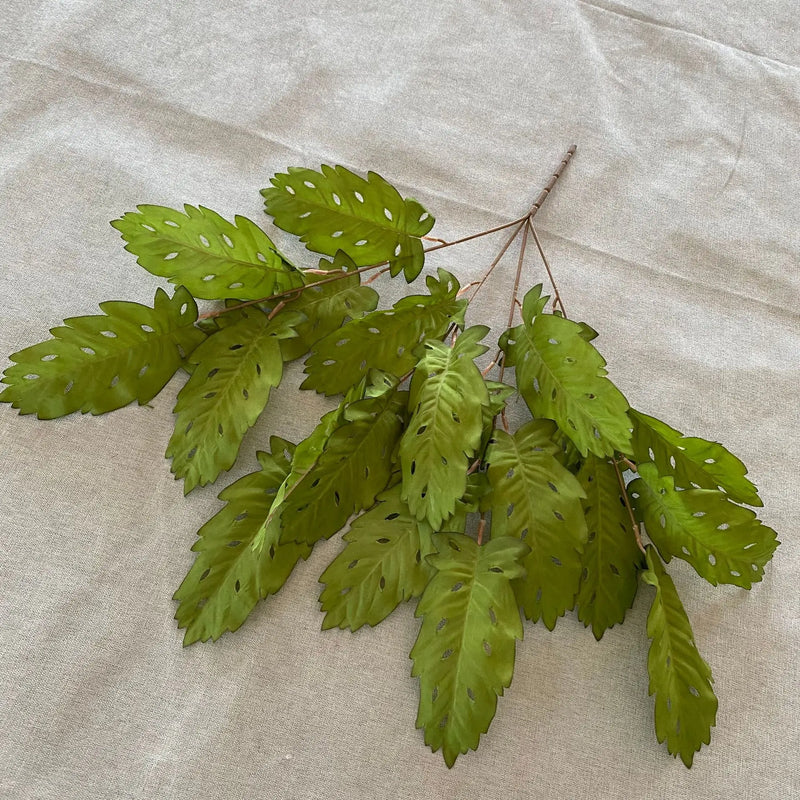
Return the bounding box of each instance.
[500,285,631,457]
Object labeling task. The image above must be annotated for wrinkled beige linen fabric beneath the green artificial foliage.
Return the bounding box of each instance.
[0,0,800,800]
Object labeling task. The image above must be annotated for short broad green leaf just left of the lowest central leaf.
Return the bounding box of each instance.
[319,485,433,631]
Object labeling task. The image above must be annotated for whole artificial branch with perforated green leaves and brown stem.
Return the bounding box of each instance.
[0,150,778,766]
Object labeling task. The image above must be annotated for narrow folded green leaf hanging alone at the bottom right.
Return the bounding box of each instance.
[642,546,717,767]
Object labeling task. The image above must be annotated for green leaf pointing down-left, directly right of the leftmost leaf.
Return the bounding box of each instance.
[166,308,298,494]
